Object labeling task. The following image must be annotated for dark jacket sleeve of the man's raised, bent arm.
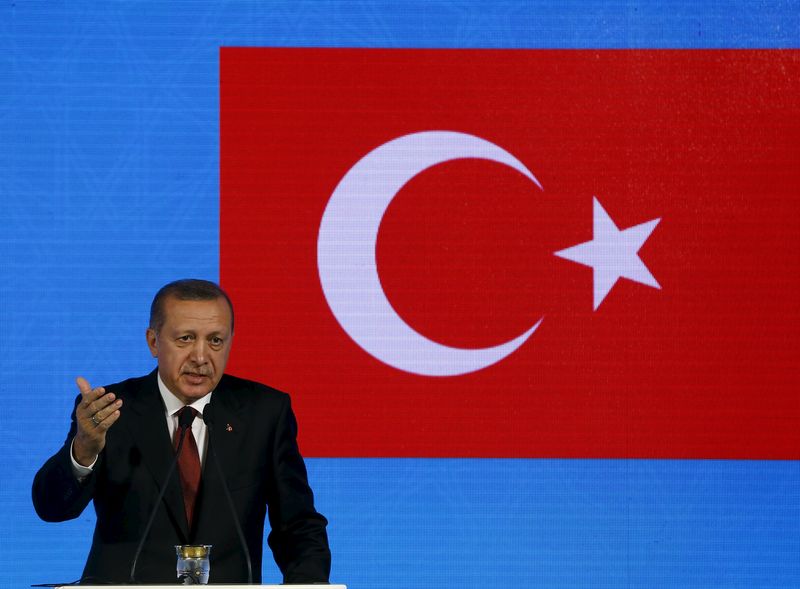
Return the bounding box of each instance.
[31,395,96,522]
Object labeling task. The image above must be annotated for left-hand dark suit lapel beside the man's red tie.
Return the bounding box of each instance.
[126,371,189,541]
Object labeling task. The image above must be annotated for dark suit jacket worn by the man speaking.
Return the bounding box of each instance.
[33,371,330,583]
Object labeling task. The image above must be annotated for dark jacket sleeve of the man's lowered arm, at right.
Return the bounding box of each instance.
[267,395,331,583]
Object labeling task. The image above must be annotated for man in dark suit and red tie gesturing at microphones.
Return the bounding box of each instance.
[33,280,330,583]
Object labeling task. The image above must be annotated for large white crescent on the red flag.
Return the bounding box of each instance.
[317,131,543,376]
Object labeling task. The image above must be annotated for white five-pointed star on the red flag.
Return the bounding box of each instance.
[555,196,661,311]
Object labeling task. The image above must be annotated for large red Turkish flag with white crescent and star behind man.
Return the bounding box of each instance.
[220,48,800,459]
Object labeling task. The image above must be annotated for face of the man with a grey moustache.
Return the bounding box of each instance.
[147,297,233,404]
